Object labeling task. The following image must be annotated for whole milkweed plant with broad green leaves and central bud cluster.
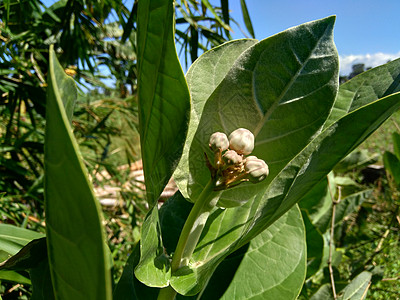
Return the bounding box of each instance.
[0,0,400,300]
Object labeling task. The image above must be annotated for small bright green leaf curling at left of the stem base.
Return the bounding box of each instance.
[135,206,171,287]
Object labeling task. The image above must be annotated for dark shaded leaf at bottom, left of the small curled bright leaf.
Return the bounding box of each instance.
[113,244,159,300]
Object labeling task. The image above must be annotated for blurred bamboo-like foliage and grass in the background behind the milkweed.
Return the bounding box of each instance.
[0,0,400,299]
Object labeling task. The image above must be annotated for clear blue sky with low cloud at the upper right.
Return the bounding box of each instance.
[227,0,400,74]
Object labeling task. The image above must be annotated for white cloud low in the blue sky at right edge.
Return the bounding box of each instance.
[339,51,400,75]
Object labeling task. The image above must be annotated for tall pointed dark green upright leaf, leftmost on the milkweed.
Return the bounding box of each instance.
[45,47,111,300]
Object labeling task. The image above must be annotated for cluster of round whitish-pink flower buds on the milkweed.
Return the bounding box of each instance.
[208,128,269,190]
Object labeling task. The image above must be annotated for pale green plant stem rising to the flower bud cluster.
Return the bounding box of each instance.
[157,179,222,300]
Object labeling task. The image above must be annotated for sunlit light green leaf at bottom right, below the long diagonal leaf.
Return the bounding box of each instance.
[221,206,306,300]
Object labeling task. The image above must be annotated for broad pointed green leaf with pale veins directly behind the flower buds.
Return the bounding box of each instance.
[175,18,338,207]
